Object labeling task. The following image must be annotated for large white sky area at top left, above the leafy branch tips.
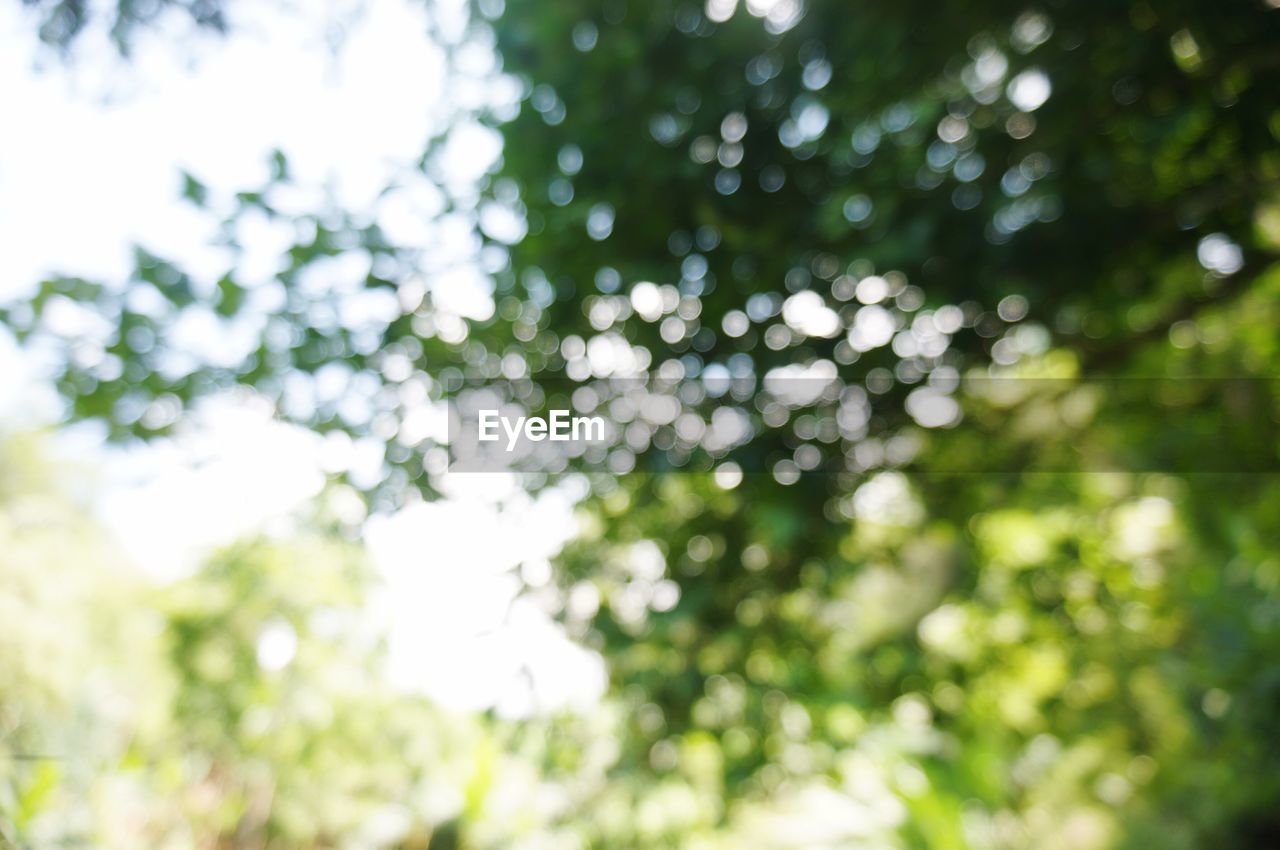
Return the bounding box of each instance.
[0,0,444,294]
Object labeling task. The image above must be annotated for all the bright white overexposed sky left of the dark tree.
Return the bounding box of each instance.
[0,0,604,714]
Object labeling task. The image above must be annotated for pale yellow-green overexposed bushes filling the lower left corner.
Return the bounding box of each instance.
[0,438,568,847]
